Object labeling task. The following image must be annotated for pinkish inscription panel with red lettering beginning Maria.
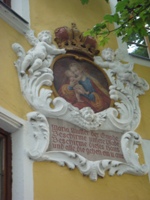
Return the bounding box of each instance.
[48,119,125,161]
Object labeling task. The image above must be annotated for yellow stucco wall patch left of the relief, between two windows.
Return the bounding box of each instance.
[0,19,32,119]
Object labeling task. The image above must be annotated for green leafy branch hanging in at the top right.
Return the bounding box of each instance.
[81,0,150,45]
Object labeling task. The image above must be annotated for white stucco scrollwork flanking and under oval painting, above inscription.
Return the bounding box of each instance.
[13,31,149,131]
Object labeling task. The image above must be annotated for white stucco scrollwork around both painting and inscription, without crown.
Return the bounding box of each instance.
[12,31,149,180]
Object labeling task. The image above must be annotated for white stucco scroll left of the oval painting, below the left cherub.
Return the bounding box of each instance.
[12,31,67,116]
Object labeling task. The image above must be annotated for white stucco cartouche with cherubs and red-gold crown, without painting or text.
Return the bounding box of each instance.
[12,24,149,180]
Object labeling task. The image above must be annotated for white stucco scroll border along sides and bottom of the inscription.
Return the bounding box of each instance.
[27,112,148,181]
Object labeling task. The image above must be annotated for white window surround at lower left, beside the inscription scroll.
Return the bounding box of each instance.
[0,107,34,200]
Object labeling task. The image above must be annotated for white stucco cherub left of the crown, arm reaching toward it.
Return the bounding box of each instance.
[20,30,66,76]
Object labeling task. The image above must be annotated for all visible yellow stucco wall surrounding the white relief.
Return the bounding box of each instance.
[0,0,150,200]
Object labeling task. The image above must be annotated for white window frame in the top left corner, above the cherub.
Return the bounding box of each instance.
[0,0,30,34]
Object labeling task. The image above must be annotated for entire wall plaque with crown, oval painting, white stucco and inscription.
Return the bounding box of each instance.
[12,23,149,180]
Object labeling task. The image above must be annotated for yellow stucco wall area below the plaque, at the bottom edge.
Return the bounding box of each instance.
[34,163,150,200]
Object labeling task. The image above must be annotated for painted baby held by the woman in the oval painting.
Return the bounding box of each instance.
[65,69,89,102]
